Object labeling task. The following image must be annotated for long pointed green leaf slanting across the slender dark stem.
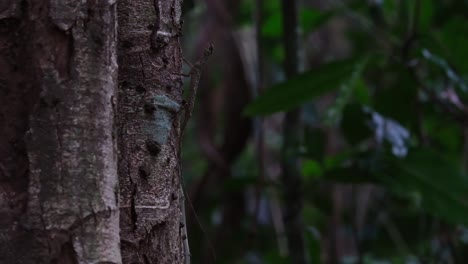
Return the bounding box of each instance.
[245,58,362,116]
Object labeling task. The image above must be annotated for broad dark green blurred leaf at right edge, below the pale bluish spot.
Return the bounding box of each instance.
[382,150,468,225]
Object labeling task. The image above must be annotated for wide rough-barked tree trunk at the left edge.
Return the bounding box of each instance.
[0,0,121,264]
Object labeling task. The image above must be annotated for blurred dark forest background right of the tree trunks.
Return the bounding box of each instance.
[178,0,468,264]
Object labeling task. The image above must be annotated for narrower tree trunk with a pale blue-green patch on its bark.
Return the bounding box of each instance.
[118,0,186,264]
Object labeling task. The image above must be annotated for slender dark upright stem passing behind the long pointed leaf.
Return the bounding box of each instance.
[281,0,307,264]
